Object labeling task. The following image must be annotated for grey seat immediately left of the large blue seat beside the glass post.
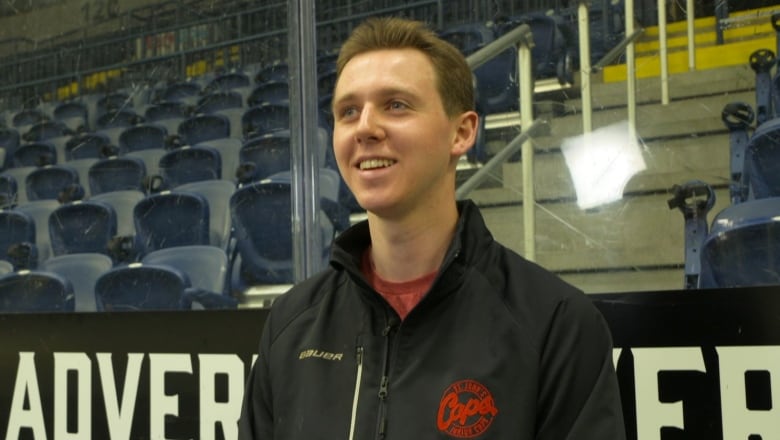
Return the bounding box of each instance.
[174,180,236,250]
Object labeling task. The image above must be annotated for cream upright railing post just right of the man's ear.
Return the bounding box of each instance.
[517,39,536,261]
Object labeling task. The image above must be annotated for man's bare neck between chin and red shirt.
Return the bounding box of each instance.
[368,201,458,282]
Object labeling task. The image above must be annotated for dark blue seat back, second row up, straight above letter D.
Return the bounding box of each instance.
[49,201,117,256]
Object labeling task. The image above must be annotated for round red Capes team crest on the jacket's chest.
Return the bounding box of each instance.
[436,379,498,438]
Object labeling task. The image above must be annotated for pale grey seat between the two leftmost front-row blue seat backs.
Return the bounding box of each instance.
[41,253,114,312]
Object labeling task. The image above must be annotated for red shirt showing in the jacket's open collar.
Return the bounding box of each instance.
[360,248,439,320]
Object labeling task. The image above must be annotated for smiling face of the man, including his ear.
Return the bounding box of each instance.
[333,49,471,217]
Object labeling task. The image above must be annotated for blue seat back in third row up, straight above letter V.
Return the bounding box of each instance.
[89,156,146,195]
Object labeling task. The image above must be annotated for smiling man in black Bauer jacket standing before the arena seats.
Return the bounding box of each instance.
[239,18,625,440]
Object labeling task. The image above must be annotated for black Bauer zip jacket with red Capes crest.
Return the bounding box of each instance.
[239,202,625,440]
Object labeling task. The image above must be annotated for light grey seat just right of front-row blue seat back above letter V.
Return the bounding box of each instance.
[142,246,228,294]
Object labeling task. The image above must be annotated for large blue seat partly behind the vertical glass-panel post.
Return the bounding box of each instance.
[230,182,333,285]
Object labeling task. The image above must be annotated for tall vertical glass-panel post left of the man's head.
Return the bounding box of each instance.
[287,0,323,282]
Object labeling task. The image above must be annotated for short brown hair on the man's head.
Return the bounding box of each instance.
[336,17,474,117]
